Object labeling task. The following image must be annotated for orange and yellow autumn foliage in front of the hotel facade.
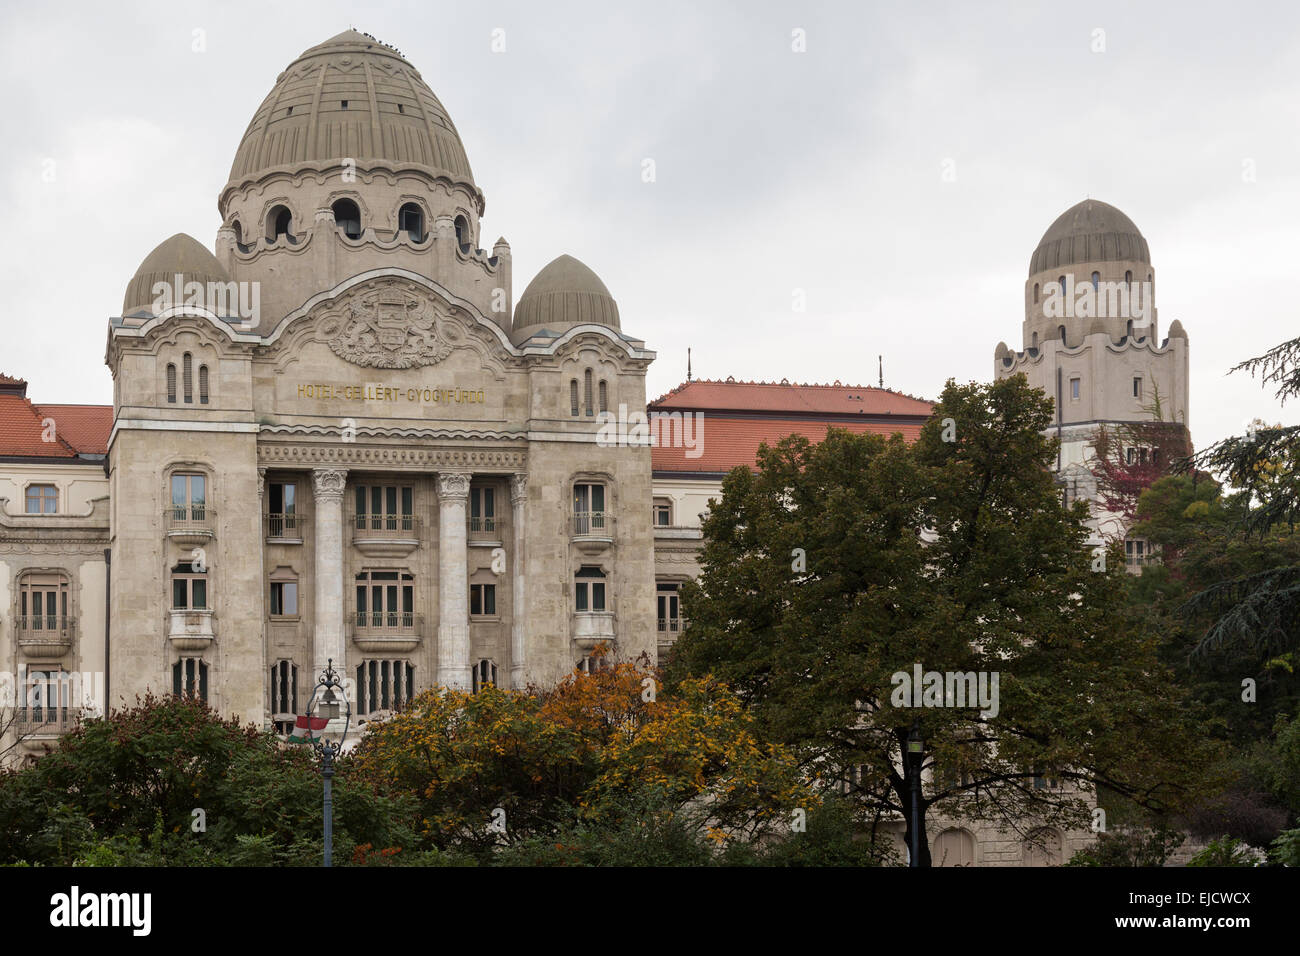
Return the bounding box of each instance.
[355,661,816,851]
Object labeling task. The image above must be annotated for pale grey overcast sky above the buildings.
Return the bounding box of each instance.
[0,0,1300,446]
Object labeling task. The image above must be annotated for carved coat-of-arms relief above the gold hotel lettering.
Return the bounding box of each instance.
[321,281,454,368]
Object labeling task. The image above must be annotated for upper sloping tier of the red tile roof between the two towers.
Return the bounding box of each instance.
[650,378,931,418]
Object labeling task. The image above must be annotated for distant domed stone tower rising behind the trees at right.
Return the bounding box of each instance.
[993,199,1188,546]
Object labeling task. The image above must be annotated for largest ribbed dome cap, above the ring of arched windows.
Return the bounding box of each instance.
[228,30,477,191]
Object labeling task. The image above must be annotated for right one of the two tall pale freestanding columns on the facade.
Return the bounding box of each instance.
[438,473,472,691]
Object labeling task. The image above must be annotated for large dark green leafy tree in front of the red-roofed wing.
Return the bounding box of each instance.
[670,376,1208,865]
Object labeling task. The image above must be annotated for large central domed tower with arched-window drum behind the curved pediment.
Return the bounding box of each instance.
[217,30,510,333]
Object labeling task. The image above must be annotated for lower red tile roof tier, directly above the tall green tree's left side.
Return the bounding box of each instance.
[650,414,920,473]
